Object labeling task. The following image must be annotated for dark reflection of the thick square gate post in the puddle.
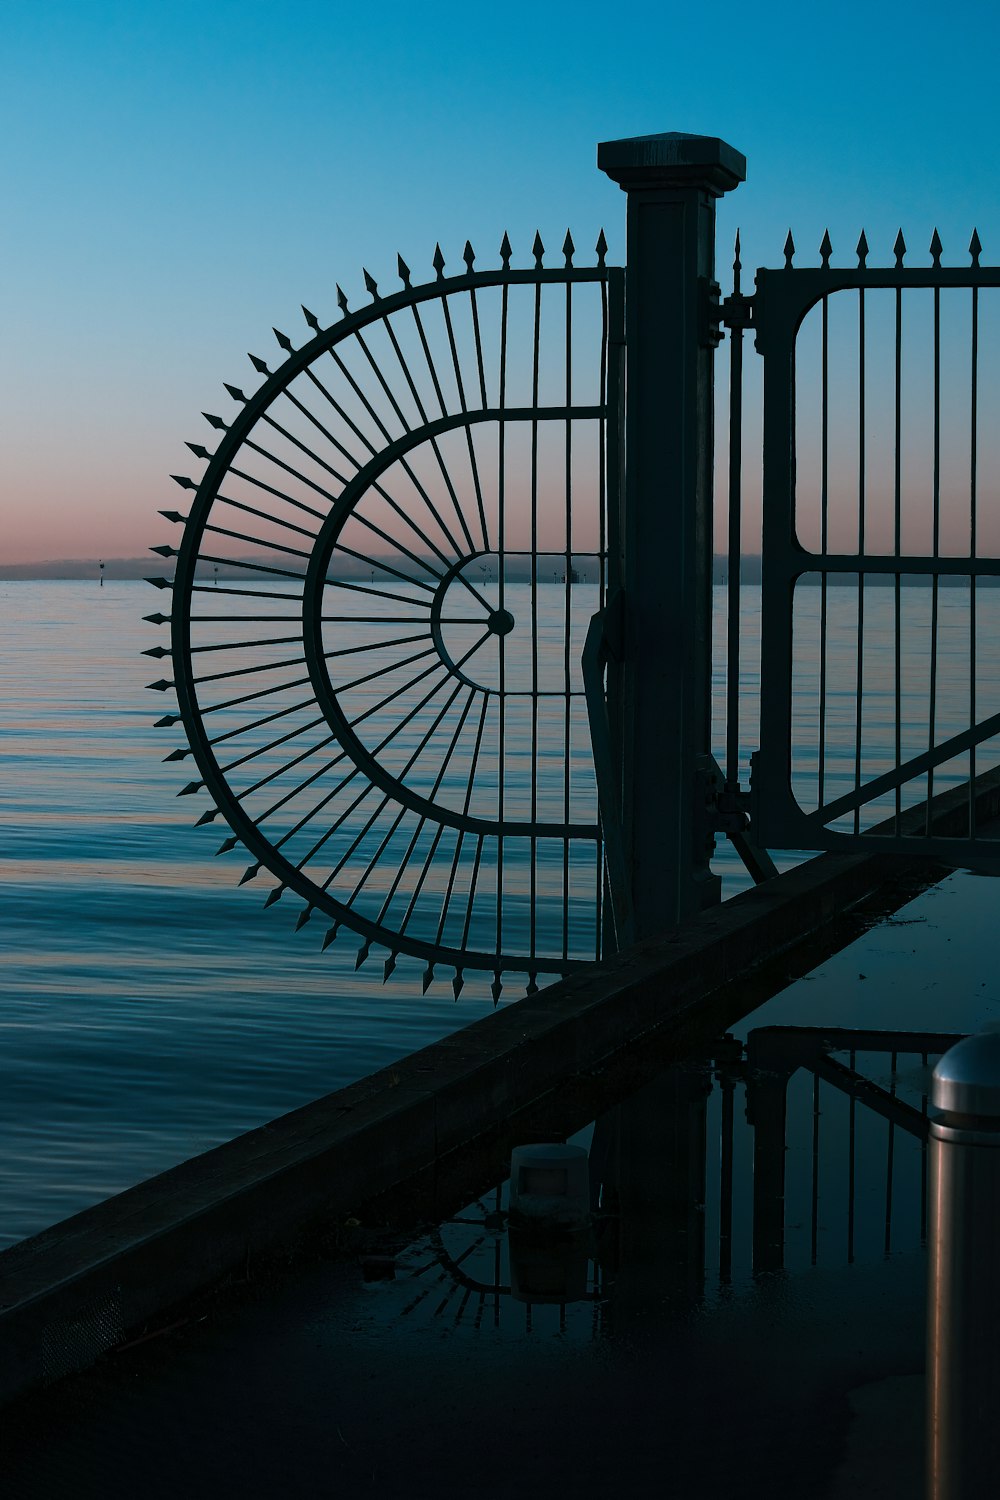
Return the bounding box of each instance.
[595,1064,711,1322]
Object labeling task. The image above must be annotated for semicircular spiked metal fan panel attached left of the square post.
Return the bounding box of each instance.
[151,234,621,998]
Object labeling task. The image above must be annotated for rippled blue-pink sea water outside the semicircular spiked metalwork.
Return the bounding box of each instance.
[0,581,1000,1245]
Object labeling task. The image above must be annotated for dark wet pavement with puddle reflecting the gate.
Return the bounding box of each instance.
[1,875,1000,1500]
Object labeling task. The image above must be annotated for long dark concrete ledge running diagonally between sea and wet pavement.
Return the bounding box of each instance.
[0,789,996,1403]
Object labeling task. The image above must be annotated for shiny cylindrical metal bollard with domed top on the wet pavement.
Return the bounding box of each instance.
[927,1032,1000,1500]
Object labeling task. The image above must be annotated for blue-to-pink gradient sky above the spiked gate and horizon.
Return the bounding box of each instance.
[0,0,1000,563]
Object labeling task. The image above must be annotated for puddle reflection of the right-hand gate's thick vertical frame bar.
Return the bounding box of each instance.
[747,1029,793,1272]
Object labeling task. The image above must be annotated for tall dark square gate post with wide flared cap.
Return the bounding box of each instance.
[597,134,747,938]
